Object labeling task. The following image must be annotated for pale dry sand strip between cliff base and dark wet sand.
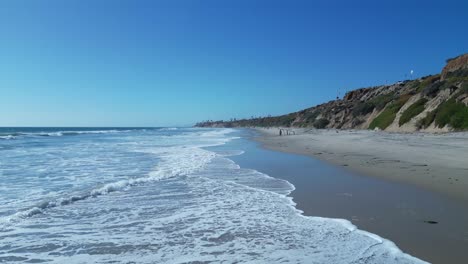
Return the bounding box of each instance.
[256,128,468,205]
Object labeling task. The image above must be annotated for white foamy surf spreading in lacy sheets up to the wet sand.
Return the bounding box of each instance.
[0,127,422,263]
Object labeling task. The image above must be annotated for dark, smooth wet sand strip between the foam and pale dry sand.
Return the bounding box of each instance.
[221,132,468,263]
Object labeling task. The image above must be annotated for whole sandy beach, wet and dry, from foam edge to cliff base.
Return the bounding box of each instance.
[245,129,468,263]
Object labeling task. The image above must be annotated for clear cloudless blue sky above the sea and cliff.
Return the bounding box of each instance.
[0,0,468,126]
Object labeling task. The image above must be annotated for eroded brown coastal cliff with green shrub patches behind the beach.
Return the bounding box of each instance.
[195,54,468,132]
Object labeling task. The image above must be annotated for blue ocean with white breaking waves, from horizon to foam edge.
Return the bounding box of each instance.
[0,128,422,263]
